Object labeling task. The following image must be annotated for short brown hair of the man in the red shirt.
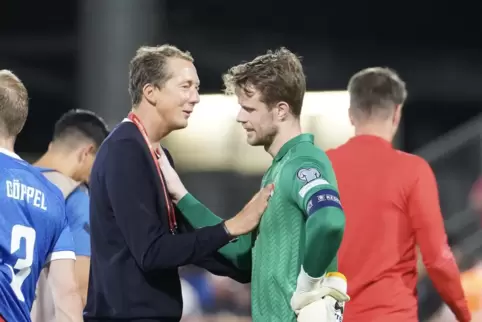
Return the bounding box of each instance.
[348,67,407,118]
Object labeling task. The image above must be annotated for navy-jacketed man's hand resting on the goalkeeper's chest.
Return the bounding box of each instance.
[225,184,274,237]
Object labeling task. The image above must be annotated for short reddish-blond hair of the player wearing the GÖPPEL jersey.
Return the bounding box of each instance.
[0,69,28,137]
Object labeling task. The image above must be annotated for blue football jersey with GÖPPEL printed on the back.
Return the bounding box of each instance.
[0,149,75,322]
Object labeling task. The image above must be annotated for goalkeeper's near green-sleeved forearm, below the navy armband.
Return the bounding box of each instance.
[303,207,345,277]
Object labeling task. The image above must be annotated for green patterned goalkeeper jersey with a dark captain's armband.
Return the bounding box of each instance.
[178,134,344,322]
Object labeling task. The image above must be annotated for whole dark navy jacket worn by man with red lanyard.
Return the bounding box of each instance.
[84,122,250,322]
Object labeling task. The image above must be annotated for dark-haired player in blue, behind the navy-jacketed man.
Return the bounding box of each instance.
[31,110,108,322]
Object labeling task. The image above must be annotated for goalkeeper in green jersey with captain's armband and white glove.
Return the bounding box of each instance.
[161,48,349,322]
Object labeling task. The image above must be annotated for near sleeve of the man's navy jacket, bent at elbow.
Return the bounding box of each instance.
[105,139,229,272]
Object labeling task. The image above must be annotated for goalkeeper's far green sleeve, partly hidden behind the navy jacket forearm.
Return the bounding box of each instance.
[177,193,252,270]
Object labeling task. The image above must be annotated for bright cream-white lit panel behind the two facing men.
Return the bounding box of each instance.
[164,91,353,173]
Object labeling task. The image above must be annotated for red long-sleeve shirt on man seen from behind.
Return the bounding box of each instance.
[327,135,470,322]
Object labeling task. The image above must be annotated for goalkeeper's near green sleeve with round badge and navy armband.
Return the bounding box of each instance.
[283,157,345,277]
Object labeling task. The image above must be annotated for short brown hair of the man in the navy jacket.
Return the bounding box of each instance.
[129,45,194,105]
